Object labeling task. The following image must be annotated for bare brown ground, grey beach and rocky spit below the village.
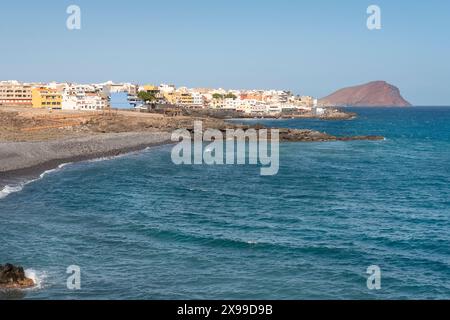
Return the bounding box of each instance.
[0,108,383,193]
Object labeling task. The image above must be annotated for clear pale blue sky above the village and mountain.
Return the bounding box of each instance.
[0,0,450,105]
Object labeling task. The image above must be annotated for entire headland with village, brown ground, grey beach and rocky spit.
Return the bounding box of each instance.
[0,81,383,185]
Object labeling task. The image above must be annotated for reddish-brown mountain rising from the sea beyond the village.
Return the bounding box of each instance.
[321,81,411,107]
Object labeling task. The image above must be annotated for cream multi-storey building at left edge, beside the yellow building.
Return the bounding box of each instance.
[0,81,32,106]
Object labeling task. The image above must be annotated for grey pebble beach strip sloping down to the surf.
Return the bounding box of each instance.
[0,132,170,190]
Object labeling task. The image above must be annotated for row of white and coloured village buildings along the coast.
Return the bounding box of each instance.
[0,80,331,117]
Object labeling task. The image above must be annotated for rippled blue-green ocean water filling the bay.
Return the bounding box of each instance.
[0,107,450,299]
